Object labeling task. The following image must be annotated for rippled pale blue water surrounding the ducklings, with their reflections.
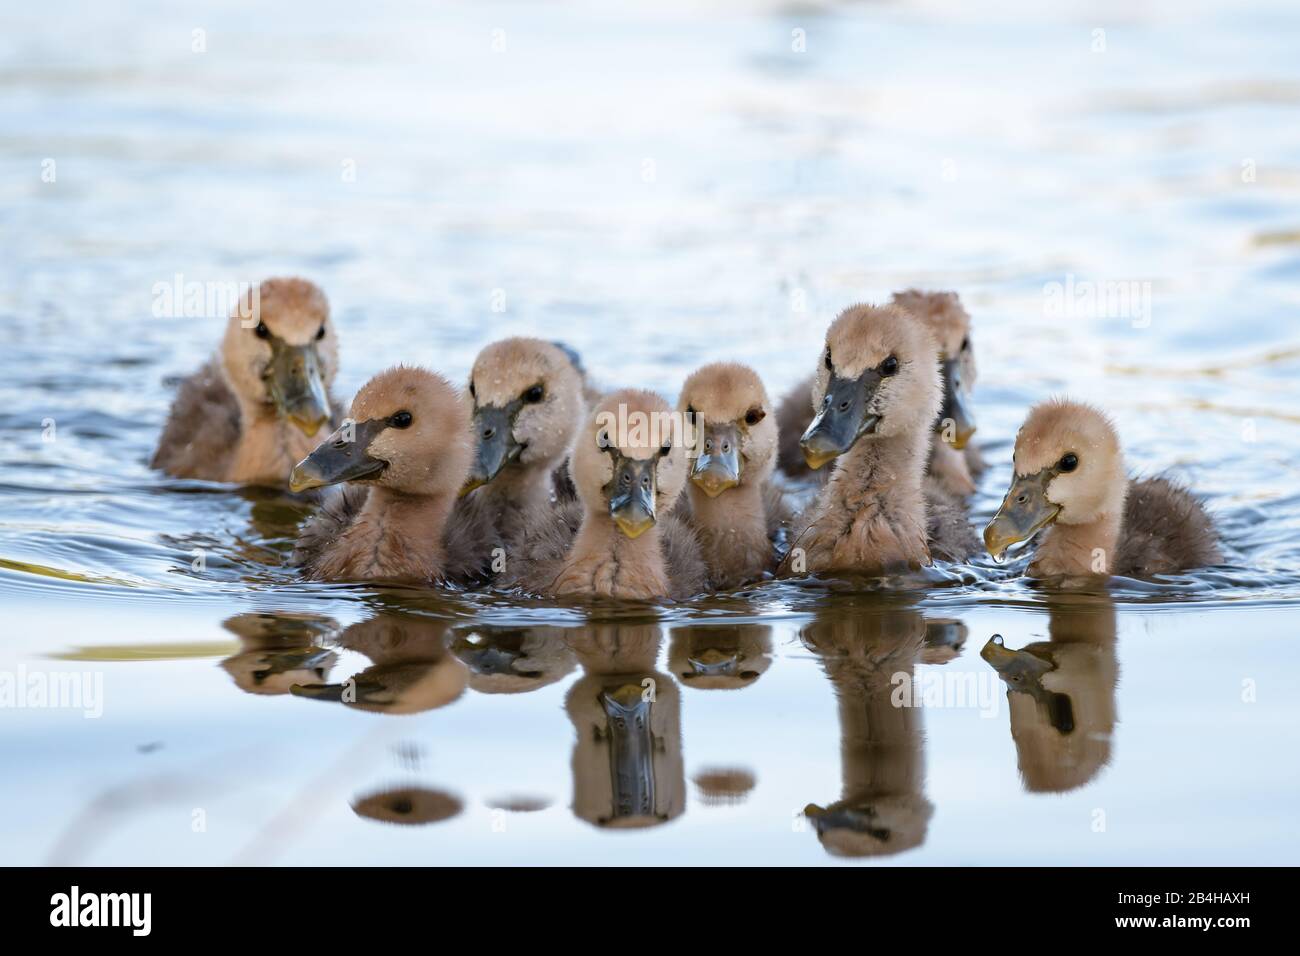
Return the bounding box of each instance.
[0,0,1300,864]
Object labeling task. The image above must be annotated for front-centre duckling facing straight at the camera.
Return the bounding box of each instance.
[502,389,707,601]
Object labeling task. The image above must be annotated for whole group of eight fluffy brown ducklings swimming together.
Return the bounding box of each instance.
[152,278,1219,600]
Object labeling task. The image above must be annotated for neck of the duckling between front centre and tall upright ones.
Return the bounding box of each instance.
[689,483,772,588]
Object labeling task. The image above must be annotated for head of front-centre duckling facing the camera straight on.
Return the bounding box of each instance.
[572,389,689,538]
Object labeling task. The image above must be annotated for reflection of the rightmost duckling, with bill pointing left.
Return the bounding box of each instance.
[980,593,1119,793]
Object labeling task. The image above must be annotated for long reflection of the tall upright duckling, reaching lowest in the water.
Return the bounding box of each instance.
[800,596,933,856]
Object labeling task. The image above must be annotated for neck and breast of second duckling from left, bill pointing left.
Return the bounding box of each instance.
[321,485,456,584]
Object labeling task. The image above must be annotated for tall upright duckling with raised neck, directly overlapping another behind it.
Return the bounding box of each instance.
[781,306,956,574]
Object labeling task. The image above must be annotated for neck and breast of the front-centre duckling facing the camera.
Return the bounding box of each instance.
[554,511,668,601]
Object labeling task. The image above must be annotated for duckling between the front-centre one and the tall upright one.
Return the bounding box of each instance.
[677,362,787,588]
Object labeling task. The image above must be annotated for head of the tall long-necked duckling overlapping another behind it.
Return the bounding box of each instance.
[800,306,941,468]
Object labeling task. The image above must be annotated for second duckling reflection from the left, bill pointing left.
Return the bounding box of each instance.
[290,613,469,714]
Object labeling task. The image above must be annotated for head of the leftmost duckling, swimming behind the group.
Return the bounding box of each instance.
[221,278,338,436]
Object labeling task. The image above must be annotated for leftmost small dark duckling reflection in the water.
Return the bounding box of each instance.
[221,613,338,695]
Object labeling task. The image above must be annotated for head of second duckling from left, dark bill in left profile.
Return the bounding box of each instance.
[289,365,473,496]
